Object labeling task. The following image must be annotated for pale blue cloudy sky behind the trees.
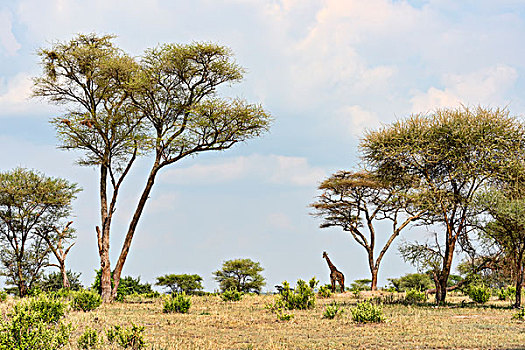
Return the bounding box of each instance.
[0,0,525,291]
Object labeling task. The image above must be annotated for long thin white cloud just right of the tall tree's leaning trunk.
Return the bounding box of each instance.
[161,154,325,186]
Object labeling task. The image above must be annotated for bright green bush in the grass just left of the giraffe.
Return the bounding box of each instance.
[276,277,316,310]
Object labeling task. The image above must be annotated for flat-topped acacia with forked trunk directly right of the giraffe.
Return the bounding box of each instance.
[311,171,423,290]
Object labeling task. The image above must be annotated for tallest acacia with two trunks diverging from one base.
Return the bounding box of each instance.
[34,34,271,302]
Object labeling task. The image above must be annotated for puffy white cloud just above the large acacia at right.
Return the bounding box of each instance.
[410,64,518,113]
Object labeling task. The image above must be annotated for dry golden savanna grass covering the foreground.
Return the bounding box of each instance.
[2,292,525,350]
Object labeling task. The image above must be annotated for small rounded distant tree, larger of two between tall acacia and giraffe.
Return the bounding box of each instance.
[213,259,266,293]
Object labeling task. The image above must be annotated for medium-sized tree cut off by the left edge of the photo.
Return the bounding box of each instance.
[0,168,79,297]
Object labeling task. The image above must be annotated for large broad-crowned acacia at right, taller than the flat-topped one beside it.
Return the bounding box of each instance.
[361,107,524,303]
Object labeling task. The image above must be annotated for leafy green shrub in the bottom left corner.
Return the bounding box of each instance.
[0,296,71,350]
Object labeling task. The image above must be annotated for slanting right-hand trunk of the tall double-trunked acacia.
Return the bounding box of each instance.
[111,165,160,298]
